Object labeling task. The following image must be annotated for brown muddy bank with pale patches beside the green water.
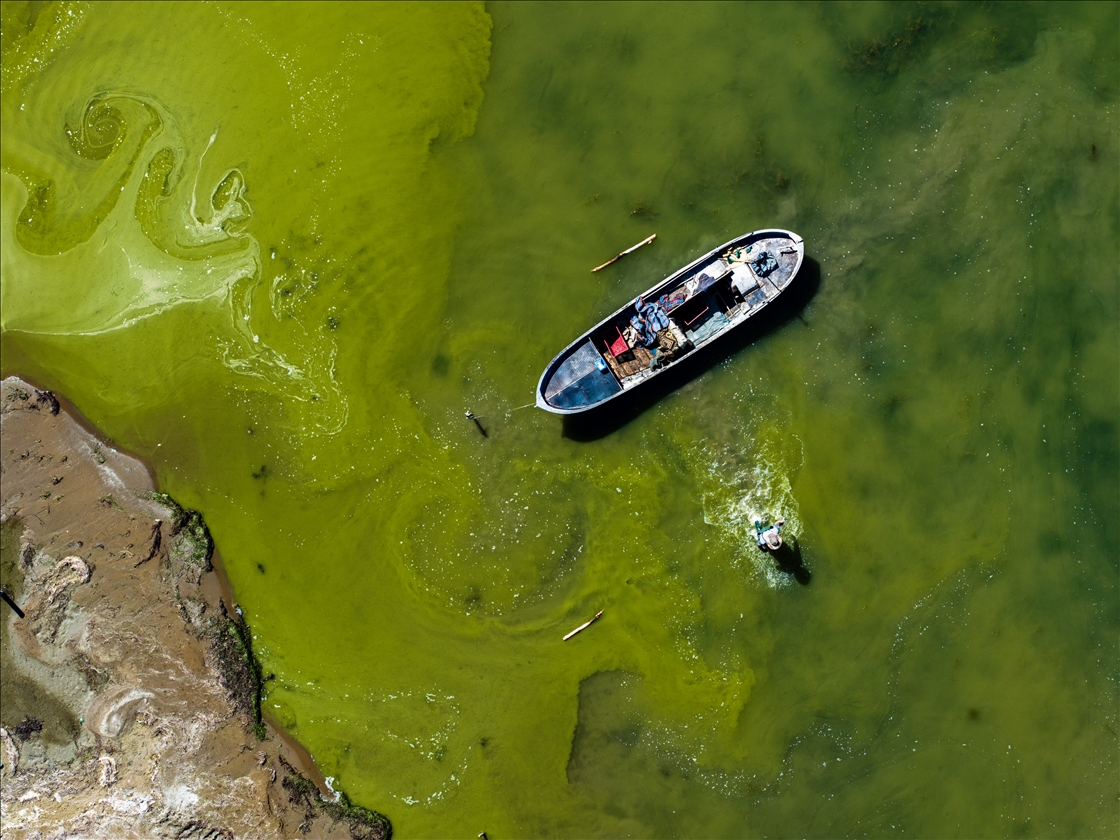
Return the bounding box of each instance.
[0,377,391,838]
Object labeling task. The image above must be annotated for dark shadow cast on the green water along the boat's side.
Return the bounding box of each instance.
[562,255,821,442]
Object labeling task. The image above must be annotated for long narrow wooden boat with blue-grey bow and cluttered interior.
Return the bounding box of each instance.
[536,228,805,414]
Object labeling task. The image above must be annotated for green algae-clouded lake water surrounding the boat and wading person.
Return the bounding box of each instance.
[0,2,1120,839]
